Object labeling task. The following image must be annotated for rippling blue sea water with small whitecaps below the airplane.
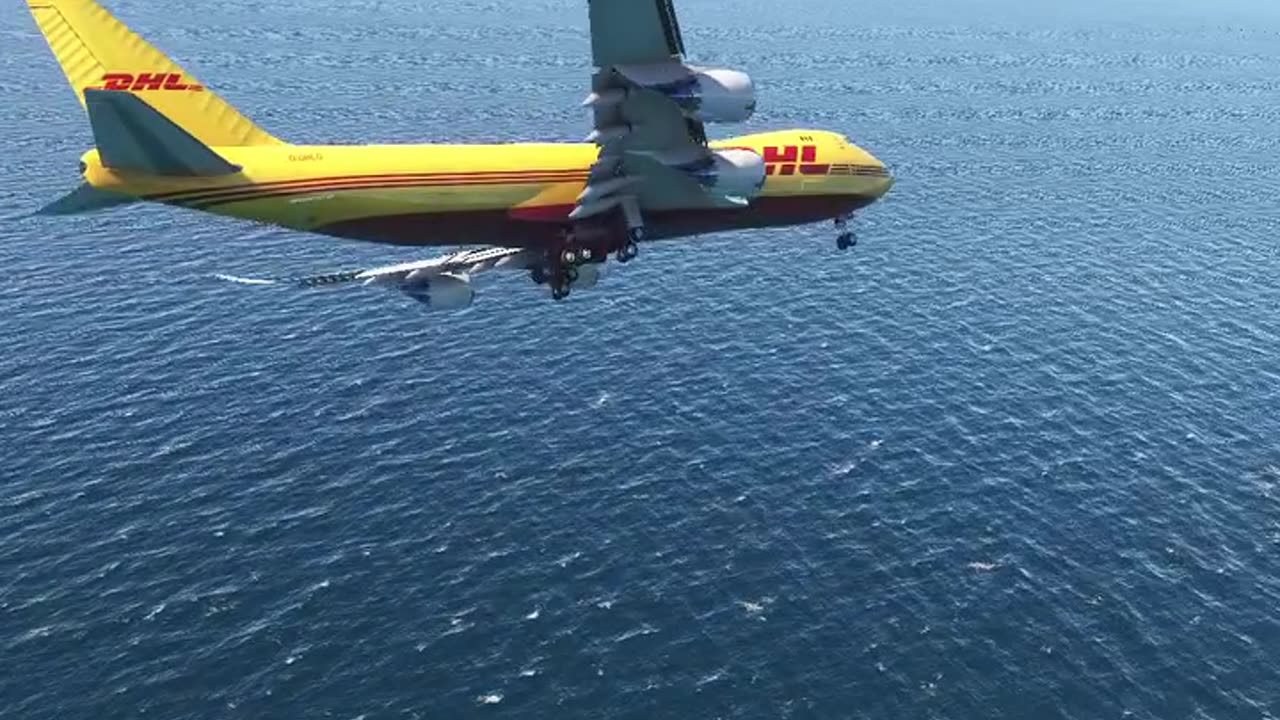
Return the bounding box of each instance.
[0,0,1280,720]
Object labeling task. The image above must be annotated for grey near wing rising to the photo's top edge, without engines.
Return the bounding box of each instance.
[571,0,736,219]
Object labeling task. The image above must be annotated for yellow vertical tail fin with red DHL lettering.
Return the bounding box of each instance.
[27,0,282,150]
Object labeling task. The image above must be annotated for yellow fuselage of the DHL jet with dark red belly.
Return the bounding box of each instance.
[83,125,893,246]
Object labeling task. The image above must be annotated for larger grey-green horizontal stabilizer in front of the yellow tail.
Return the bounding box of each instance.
[84,90,241,177]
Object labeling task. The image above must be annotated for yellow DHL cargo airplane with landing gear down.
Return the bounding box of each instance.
[27,0,893,309]
